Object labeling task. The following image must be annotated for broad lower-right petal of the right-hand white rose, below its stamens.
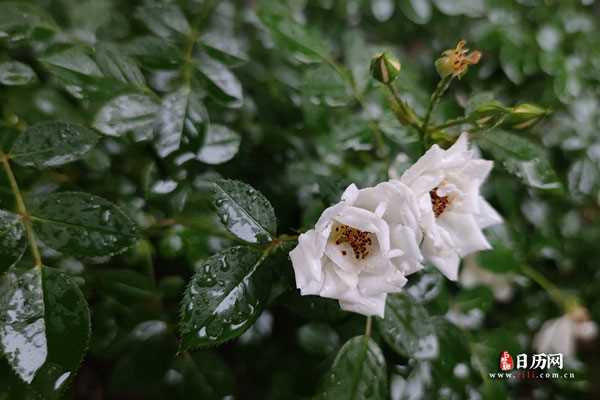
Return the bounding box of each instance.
[437,211,491,257]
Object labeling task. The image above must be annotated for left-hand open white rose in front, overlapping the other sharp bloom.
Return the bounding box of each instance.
[290,182,422,317]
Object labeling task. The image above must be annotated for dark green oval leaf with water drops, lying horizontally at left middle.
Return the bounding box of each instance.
[29,192,138,257]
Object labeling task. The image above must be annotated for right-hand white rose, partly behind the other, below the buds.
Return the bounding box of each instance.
[400,133,502,280]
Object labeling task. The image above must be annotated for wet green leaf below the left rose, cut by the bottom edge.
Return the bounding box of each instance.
[316,336,389,400]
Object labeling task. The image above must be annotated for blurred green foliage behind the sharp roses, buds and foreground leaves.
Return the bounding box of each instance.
[0,0,600,400]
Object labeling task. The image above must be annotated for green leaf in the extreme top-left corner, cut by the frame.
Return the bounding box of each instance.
[0,1,58,42]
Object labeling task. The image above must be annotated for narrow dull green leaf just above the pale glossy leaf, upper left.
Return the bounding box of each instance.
[96,43,146,87]
